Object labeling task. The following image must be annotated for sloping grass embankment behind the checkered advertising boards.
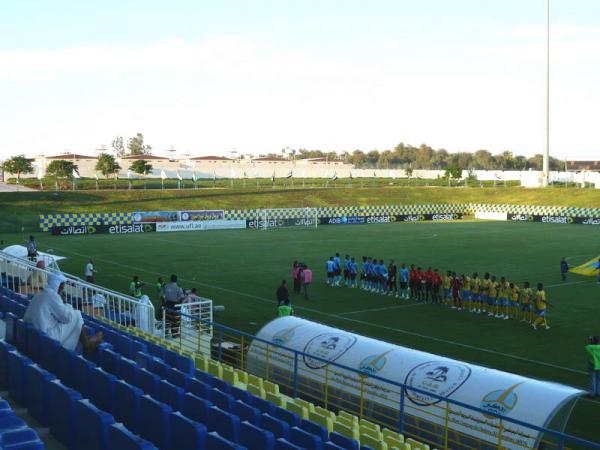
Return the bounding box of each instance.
[0,184,600,233]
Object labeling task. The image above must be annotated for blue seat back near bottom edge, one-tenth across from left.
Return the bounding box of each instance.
[48,380,81,448]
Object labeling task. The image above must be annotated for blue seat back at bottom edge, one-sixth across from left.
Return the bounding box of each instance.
[74,399,115,450]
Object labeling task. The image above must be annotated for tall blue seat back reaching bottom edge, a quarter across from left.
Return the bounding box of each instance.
[139,395,173,450]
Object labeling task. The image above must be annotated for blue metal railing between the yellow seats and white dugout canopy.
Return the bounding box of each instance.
[165,310,600,450]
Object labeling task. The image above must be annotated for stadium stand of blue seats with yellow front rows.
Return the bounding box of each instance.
[0,287,422,450]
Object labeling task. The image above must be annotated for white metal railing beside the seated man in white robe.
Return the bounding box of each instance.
[0,251,155,334]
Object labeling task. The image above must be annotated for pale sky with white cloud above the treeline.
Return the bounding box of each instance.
[0,0,600,159]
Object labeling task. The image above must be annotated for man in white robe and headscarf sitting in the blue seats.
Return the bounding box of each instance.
[23,273,103,353]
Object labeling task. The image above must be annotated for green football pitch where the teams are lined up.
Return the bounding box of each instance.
[0,221,600,441]
